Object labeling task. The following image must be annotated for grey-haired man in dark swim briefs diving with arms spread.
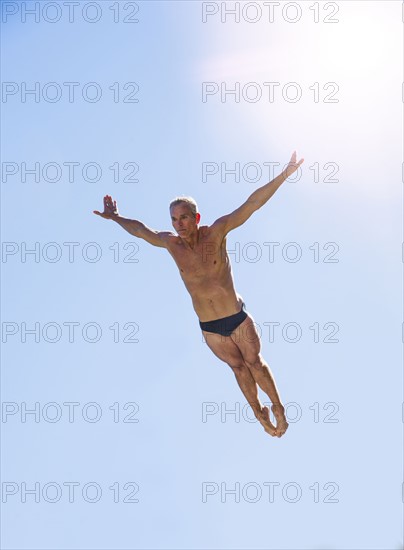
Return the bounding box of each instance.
[94,151,304,437]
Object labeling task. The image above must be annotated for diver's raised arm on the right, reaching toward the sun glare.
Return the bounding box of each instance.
[213,151,304,234]
